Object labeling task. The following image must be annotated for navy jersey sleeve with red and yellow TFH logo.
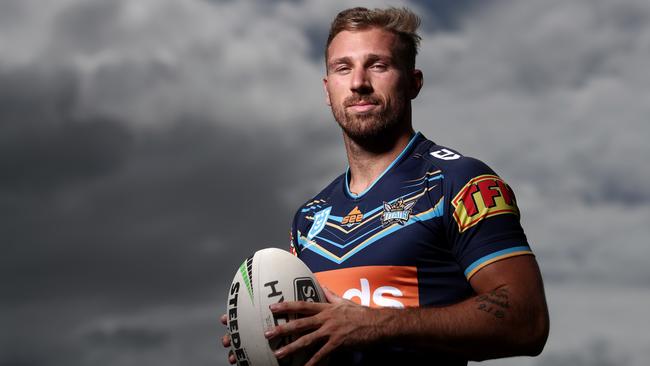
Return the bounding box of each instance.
[443,157,532,280]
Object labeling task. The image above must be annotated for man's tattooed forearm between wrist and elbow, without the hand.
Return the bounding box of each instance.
[370,285,548,360]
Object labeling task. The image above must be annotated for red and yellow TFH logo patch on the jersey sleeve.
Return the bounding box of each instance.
[451,174,519,233]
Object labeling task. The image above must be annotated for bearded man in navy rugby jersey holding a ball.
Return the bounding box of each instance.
[222,8,549,365]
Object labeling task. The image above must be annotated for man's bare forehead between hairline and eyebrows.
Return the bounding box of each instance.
[327,28,397,62]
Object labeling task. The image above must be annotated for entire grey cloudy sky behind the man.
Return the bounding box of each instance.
[0,0,650,366]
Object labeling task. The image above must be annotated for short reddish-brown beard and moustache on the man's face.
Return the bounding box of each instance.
[332,94,410,152]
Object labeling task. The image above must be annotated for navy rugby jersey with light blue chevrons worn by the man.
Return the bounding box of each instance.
[291,133,532,365]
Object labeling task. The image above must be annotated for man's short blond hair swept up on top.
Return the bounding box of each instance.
[325,7,422,70]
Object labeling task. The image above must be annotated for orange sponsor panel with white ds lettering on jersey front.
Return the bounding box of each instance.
[315,266,420,308]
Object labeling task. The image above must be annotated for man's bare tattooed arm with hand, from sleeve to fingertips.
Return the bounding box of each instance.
[265,256,549,365]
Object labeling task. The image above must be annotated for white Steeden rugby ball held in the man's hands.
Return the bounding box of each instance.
[226,248,326,366]
